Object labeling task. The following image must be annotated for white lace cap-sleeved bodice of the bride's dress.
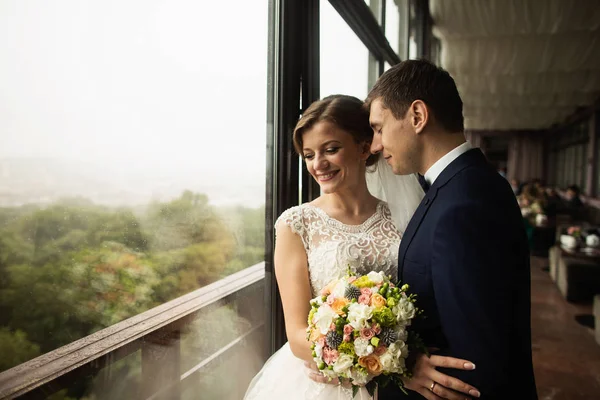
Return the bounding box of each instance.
[275,201,402,296]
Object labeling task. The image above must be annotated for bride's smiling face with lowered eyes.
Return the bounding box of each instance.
[302,121,370,193]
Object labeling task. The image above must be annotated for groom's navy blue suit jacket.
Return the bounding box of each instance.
[380,149,537,400]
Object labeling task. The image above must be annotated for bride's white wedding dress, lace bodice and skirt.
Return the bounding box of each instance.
[244,201,401,400]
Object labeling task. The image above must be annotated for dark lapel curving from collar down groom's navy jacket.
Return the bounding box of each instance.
[398,148,487,281]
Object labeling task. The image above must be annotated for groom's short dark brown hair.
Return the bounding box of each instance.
[365,60,464,133]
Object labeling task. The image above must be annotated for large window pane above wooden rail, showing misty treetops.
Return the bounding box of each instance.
[0,0,268,371]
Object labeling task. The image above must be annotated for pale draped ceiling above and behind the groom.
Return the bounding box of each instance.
[429,0,600,130]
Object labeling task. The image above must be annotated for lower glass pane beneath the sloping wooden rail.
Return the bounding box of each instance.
[24,280,266,400]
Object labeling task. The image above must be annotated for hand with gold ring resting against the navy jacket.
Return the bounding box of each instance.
[403,354,480,400]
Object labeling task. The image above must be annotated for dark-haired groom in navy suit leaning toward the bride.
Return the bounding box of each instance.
[366,60,537,400]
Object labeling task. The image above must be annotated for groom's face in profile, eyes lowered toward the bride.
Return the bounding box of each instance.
[369,99,419,175]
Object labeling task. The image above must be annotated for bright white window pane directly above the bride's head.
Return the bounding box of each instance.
[320,0,369,99]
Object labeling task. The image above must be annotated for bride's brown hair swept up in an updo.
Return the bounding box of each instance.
[293,94,379,167]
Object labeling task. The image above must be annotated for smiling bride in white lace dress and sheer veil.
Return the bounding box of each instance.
[244,95,473,400]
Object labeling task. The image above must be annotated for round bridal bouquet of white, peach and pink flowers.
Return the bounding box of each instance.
[307,272,426,396]
